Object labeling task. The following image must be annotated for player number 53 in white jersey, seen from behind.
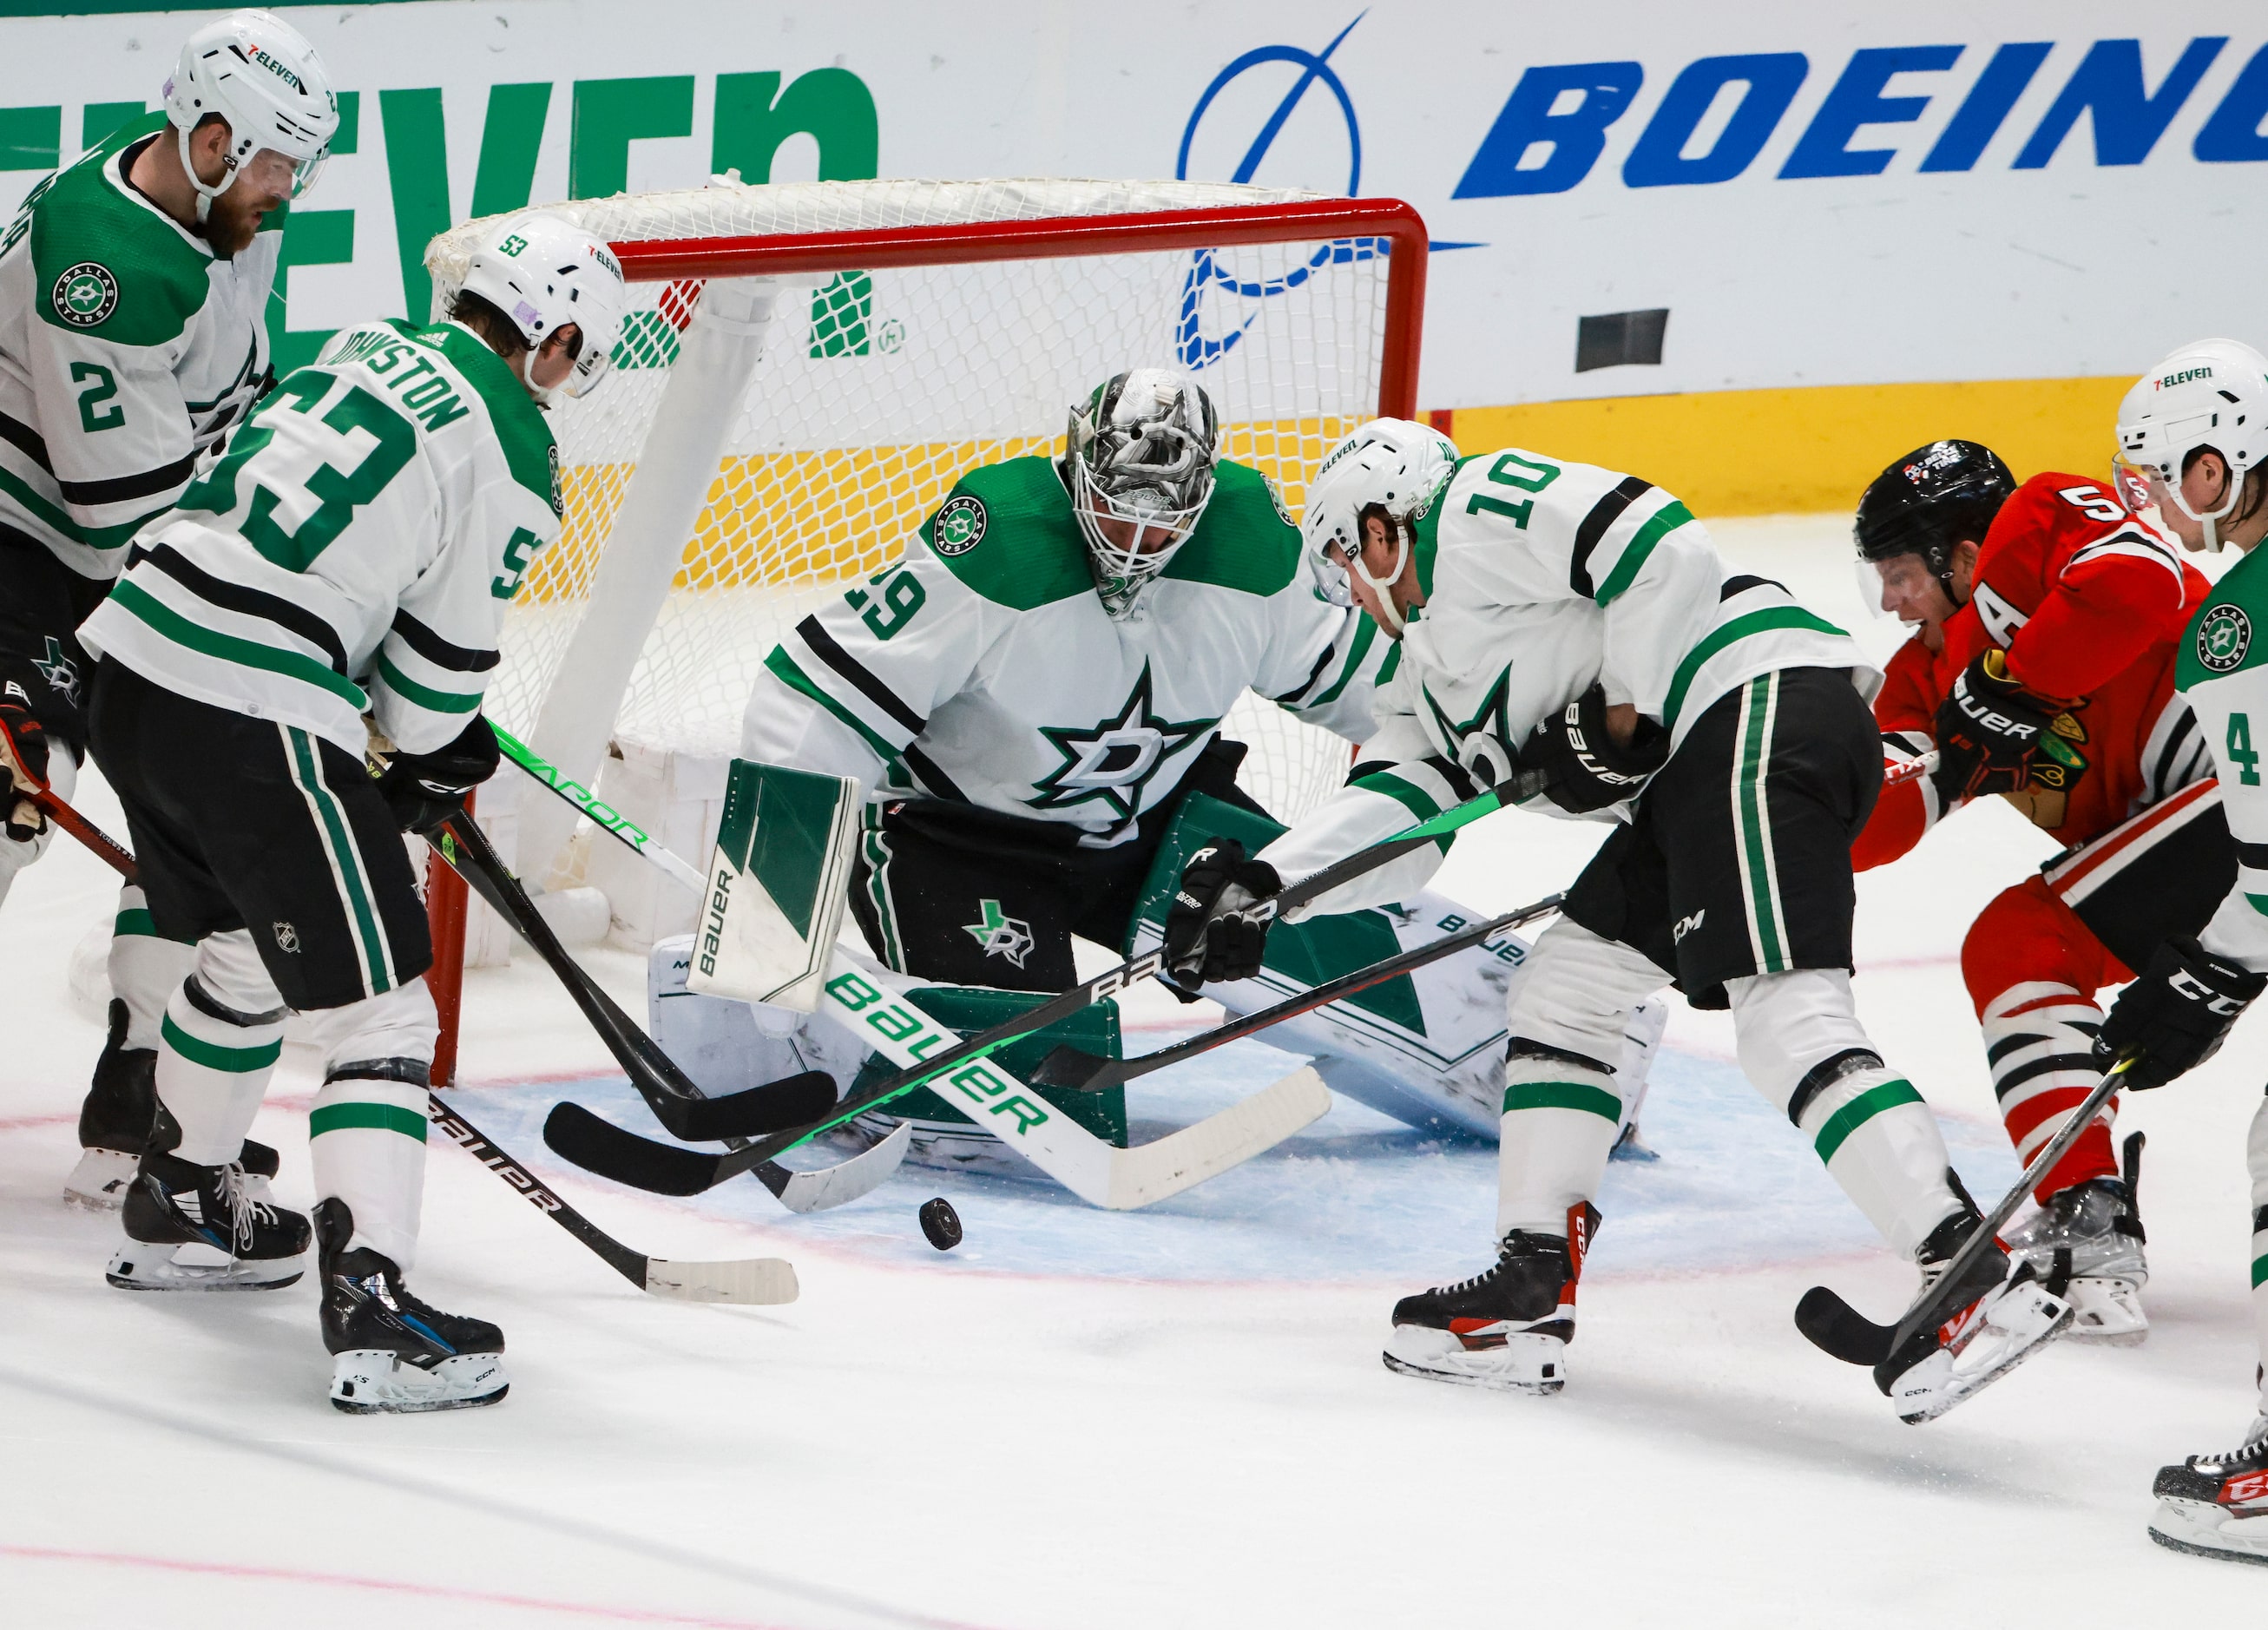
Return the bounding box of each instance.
[82,214,624,1412]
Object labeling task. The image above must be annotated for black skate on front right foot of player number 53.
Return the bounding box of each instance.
[315,1199,510,1415]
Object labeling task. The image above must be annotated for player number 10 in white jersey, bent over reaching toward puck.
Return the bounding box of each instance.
[1166,419,2071,1422]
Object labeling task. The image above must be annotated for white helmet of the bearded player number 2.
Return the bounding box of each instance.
[163,11,338,220]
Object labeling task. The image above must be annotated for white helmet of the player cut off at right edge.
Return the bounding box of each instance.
[2114,340,2268,553]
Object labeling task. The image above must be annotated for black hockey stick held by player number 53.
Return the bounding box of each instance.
[426,814,835,1142]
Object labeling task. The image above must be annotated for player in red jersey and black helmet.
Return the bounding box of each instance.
[1853,442,2236,1344]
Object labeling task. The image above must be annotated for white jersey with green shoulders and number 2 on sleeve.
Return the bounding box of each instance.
[0,114,284,578]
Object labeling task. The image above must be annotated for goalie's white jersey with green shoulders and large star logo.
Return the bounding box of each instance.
[741,458,1392,848]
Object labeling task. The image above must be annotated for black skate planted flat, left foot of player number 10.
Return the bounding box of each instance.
[1384,1204,1599,1394]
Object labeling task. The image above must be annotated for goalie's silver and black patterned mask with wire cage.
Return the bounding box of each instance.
[1057,367,1220,616]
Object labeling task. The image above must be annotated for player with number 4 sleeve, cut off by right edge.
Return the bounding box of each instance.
[2095,340,2268,1564]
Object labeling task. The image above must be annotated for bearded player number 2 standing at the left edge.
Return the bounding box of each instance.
[0,11,338,1206]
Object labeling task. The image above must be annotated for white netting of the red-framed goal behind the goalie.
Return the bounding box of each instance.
[426,181,1388,829]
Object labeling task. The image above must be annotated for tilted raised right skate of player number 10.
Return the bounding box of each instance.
[1873,1208,2071,1426]
